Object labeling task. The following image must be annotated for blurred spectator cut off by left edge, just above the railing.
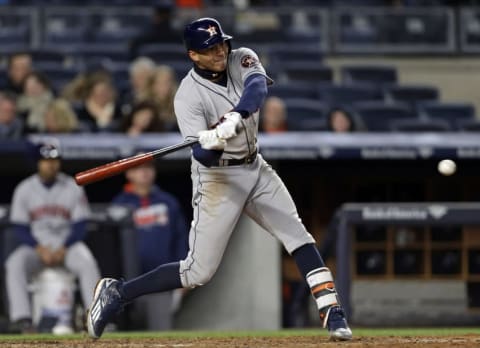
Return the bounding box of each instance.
[0,92,23,139]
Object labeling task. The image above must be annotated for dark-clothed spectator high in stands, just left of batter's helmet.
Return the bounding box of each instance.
[130,5,179,58]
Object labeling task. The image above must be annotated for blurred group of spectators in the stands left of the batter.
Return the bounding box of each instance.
[0,53,177,139]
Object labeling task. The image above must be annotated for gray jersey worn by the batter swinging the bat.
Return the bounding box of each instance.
[175,48,268,159]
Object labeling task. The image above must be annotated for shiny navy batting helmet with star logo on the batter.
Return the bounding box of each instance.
[183,18,233,51]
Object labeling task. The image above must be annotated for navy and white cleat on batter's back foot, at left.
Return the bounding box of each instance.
[87,278,125,338]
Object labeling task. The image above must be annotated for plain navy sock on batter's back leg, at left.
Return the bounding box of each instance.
[119,262,183,301]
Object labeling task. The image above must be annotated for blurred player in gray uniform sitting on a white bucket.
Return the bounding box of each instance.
[5,143,100,331]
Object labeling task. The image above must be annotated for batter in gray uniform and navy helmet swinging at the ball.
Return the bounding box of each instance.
[87,18,352,340]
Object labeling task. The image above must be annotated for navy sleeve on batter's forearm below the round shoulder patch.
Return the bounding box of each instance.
[234,74,268,118]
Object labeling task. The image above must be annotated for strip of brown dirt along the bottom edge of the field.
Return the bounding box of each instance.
[0,335,480,348]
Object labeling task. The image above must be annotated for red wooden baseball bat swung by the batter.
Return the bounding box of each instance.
[75,139,198,186]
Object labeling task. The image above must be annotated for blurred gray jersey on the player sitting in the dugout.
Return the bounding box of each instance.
[10,173,90,249]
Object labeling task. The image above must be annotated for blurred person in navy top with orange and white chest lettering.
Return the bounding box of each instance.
[112,162,188,330]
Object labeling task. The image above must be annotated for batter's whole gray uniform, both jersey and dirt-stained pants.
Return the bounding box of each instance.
[175,48,315,287]
